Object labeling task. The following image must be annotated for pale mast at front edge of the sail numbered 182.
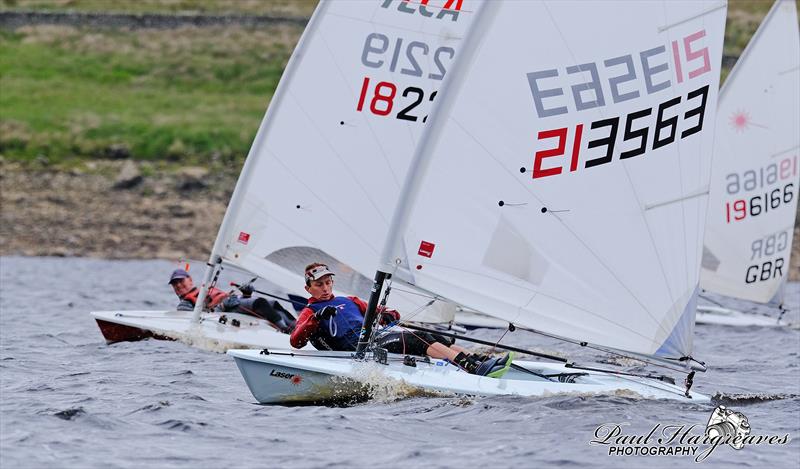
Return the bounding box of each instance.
[192,0,329,323]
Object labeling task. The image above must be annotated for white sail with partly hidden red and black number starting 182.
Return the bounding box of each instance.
[212,0,476,320]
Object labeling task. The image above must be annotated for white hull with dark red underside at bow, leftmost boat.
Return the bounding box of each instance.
[91,311,310,352]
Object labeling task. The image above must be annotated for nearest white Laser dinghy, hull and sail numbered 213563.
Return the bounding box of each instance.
[228,1,726,403]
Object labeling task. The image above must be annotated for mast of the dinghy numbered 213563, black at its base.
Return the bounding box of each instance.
[356,1,499,358]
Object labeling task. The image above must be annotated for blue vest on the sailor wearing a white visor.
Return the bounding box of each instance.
[308,296,364,351]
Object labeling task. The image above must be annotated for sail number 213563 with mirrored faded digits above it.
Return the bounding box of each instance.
[532,29,718,180]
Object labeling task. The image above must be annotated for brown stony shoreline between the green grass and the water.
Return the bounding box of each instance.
[0,160,800,281]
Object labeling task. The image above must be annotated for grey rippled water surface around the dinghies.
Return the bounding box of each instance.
[0,258,800,469]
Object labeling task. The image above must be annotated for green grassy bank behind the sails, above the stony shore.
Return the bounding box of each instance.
[0,0,788,167]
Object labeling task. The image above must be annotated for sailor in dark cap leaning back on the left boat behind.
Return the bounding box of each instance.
[169,269,295,334]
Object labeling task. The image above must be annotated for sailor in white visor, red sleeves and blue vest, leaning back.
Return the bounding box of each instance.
[290,262,512,378]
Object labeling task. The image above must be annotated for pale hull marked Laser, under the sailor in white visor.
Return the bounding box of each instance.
[228,350,710,404]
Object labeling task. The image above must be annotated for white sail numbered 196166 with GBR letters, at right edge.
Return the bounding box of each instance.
[700,1,800,303]
